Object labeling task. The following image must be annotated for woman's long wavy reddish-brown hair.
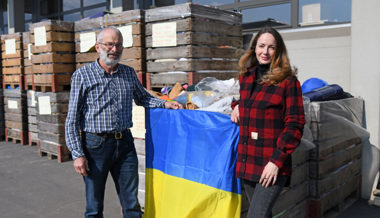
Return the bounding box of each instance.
[239,27,297,85]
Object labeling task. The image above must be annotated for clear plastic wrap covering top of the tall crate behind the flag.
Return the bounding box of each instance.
[145,3,242,25]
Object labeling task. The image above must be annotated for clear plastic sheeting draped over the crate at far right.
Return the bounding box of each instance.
[304,98,380,199]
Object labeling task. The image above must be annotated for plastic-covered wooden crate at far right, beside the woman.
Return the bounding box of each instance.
[307,98,364,217]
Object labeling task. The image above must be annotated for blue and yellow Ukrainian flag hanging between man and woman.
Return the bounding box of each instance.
[144,108,241,218]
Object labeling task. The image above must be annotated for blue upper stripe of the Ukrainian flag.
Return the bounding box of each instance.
[146,108,240,194]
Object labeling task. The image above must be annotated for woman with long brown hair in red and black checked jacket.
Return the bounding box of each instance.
[231,27,305,218]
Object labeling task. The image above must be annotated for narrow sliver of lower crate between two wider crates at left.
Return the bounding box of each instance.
[26,90,39,146]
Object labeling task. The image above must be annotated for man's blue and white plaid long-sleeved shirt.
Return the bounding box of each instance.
[65,61,165,159]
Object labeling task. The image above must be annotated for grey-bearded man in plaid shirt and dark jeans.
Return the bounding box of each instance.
[65,27,182,218]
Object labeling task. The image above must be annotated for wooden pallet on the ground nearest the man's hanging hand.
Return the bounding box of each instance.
[37,141,71,163]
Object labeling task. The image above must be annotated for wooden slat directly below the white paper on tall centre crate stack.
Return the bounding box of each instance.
[147,45,236,60]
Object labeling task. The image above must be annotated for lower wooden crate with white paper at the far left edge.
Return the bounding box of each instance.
[3,89,28,145]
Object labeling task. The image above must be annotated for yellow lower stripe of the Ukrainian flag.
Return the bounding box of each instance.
[144,168,241,218]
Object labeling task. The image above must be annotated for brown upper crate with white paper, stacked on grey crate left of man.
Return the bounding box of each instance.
[29,20,75,92]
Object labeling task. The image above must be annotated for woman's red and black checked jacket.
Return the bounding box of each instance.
[232,69,305,181]
